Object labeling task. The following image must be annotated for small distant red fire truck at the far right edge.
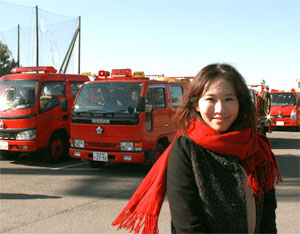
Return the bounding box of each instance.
[271,89,300,131]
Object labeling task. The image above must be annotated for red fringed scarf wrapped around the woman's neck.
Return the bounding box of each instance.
[112,119,282,234]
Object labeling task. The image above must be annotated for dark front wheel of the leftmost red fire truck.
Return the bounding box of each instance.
[47,133,68,162]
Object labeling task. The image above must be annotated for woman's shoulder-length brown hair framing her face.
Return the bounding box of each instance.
[175,63,256,131]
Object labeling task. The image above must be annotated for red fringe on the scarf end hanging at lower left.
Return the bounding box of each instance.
[111,210,158,234]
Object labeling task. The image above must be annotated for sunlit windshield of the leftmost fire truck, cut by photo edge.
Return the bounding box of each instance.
[0,80,39,111]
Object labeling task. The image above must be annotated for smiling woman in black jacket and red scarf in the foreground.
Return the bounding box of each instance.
[113,64,281,233]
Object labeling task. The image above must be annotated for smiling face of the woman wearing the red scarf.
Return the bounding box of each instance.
[196,78,239,133]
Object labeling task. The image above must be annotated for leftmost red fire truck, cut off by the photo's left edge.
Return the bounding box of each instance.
[0,67,90,161]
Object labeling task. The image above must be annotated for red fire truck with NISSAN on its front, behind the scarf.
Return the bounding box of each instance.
[70,69,187,167]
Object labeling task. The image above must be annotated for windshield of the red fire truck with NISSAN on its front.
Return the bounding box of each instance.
[73,82,143,113]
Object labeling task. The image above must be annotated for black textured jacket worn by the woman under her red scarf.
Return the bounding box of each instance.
[167,136,277,233]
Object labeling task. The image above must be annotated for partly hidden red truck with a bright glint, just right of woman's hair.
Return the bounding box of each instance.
[248,82,272,135]
